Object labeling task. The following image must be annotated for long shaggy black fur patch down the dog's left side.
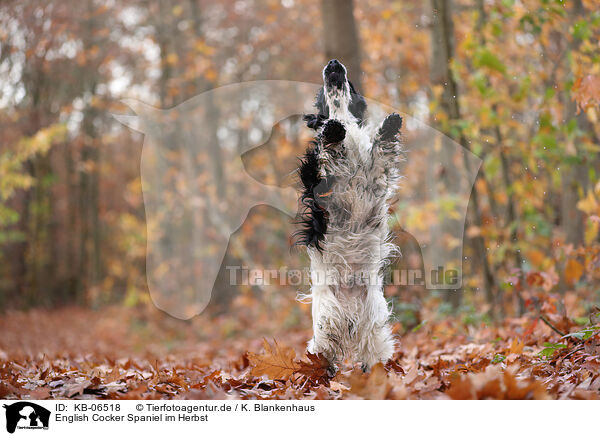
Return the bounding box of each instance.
[294,143,328,251]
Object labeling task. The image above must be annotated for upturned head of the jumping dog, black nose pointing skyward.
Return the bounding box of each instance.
[315,59,367,125]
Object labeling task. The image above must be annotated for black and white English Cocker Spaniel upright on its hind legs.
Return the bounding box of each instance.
[298,59,402,374]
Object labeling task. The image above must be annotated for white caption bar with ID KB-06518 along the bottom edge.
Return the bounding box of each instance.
[0,400,598,436]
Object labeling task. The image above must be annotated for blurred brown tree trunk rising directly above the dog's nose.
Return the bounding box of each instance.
[321,0,362,93]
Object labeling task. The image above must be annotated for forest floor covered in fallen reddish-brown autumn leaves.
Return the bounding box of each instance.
[0,307,600,399]
